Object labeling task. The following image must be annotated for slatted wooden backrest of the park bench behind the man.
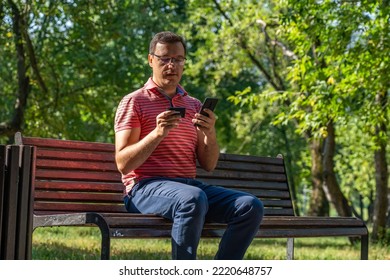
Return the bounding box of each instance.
[19,137,294,216]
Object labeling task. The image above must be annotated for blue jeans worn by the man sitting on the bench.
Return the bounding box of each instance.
[124,178,264,260]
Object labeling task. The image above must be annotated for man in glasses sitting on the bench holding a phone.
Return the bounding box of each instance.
[115,32,263,259]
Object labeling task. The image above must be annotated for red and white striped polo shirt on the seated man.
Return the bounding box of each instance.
[114,78,202,193]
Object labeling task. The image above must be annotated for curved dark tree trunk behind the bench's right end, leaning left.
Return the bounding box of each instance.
[323,121,352,217]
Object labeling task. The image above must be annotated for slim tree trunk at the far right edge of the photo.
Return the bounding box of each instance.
[371,94,389,242]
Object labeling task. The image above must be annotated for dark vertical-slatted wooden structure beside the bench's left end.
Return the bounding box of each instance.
[0,145,34,260]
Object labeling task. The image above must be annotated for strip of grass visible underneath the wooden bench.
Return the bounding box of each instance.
[32,239,359,260]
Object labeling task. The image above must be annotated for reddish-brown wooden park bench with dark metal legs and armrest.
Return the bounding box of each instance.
[15,133,368,259]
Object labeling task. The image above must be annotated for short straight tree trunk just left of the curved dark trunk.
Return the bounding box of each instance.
[307,139,329,216]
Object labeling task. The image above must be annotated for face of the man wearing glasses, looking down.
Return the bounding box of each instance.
[148,42,185,94]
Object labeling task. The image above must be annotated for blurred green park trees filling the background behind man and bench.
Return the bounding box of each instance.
[0,0,390,241]
